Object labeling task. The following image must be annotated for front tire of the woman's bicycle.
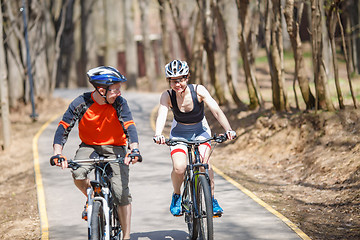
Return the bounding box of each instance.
[196,175,214,240]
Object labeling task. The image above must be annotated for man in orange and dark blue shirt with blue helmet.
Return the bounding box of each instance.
[52,66,140,239]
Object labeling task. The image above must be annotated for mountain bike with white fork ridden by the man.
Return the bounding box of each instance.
[50,152,142,240]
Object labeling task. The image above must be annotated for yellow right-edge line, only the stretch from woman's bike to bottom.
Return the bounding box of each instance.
[212,165,311,240]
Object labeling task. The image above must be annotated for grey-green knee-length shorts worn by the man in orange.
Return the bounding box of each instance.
[72,143,132,206]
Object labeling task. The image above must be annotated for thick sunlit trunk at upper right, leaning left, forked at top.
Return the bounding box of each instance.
[284,0,315,109]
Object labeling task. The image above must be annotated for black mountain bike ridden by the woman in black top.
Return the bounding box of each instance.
[166,135,227,240]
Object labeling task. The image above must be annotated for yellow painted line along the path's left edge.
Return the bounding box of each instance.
[33,115,59,240]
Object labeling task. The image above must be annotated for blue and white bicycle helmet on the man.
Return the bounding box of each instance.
[87,66,127,88]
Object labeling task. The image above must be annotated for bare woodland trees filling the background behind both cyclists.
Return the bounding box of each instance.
[1,0,360,127]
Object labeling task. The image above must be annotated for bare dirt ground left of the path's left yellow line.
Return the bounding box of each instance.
[0,99,67,240]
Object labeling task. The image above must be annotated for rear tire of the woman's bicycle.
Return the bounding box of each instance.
[182,175,199,240]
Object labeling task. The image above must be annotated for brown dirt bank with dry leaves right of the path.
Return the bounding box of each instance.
[209,109,360,240]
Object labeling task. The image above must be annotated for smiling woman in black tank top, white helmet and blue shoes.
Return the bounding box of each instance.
[154,60,236,216]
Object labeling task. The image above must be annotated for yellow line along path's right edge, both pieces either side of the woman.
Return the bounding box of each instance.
[150,105,311,240]
